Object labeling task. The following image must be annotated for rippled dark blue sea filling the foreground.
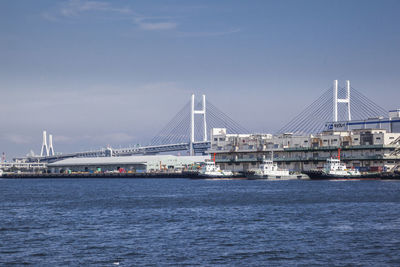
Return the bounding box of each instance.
[0,179,400,266]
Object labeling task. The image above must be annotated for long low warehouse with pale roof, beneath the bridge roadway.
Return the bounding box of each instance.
[48,155,210,173]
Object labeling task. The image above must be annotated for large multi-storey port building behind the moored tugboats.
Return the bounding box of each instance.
[208,110,400,171]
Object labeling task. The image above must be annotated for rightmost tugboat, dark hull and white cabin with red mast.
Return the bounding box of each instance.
[303,149,378,180]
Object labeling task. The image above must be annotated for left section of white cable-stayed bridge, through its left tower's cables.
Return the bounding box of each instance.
[28,94,249,162]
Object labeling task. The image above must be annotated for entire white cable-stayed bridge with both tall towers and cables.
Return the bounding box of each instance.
[28,80,388,162]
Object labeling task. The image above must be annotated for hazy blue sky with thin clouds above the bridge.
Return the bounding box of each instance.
[0,0,400,159]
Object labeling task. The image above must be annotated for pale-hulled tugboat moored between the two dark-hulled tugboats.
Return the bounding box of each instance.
[245,153,304,180]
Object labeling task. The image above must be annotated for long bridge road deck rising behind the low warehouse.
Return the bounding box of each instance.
[27,141,211,162]
